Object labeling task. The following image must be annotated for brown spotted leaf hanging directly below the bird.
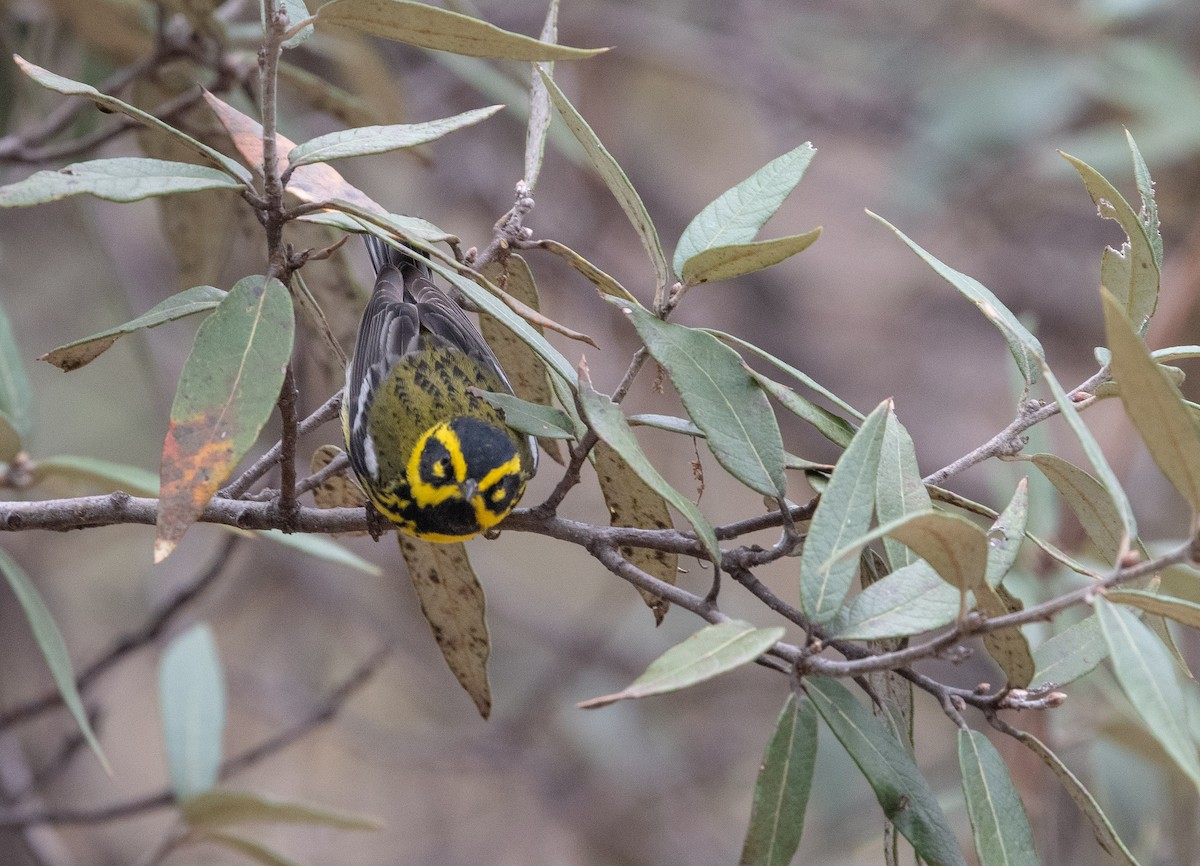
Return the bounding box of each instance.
[396,533,492,718]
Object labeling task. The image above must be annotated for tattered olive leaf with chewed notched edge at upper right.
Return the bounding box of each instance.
[1060,151,1159,331]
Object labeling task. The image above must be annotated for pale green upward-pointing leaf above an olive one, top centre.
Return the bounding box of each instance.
[674,142,820,277]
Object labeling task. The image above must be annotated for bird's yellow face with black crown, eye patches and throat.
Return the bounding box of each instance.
[406,416,527,542]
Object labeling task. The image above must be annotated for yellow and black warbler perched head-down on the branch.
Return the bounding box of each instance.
[342,236,538,542]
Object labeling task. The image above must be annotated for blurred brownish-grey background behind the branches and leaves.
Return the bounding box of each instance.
[0,0,1200,866]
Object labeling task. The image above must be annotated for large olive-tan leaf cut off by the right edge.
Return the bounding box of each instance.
[1100,286,1200,513]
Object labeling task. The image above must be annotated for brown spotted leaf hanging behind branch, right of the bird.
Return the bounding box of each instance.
[592,443,679,625]
